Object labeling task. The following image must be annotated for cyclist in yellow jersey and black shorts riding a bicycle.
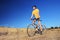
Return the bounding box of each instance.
[31,5,42,34]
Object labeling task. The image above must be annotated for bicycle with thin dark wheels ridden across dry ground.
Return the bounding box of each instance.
[27,19,46,37]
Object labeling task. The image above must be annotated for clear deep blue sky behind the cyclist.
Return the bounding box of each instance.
[0,0,60,28]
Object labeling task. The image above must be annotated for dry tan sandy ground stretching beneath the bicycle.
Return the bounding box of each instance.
[0,28,60,40]
